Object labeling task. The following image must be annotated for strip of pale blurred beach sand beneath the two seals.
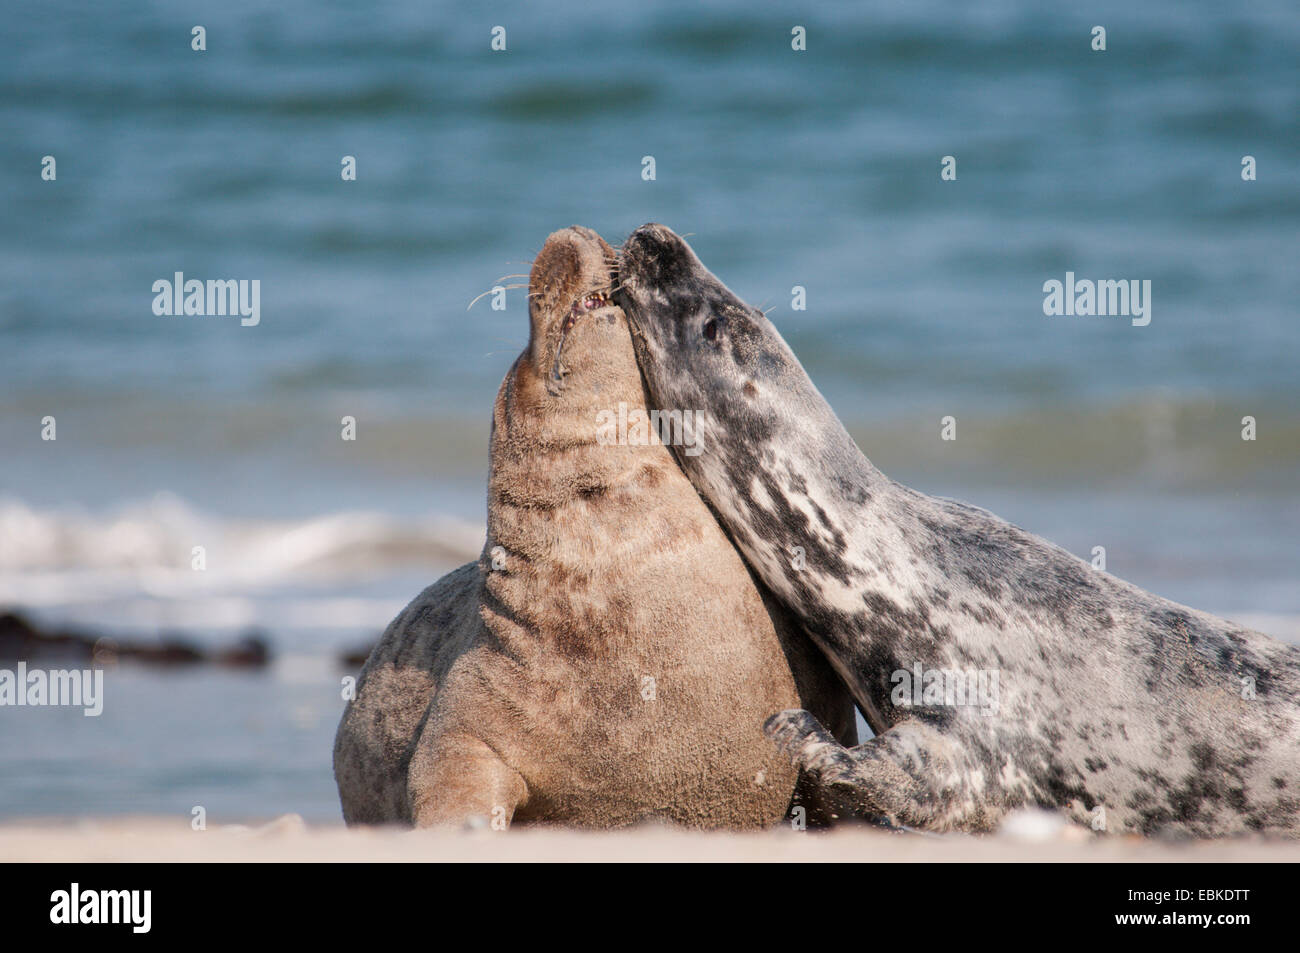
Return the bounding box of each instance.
[0,815,1300,863]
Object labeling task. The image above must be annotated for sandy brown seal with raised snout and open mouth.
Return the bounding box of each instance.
[334,228,854,828]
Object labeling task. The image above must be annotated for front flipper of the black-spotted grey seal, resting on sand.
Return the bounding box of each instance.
[763,709,980,831]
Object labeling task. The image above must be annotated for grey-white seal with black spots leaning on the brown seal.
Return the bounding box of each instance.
[615,225,1300,836]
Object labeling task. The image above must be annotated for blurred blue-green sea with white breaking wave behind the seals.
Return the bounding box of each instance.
[0,0,1300,824]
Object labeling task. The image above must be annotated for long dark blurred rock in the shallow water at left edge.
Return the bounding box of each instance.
[0,612,270,668]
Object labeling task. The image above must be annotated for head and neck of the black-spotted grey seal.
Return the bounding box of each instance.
[614,225,871,605]
